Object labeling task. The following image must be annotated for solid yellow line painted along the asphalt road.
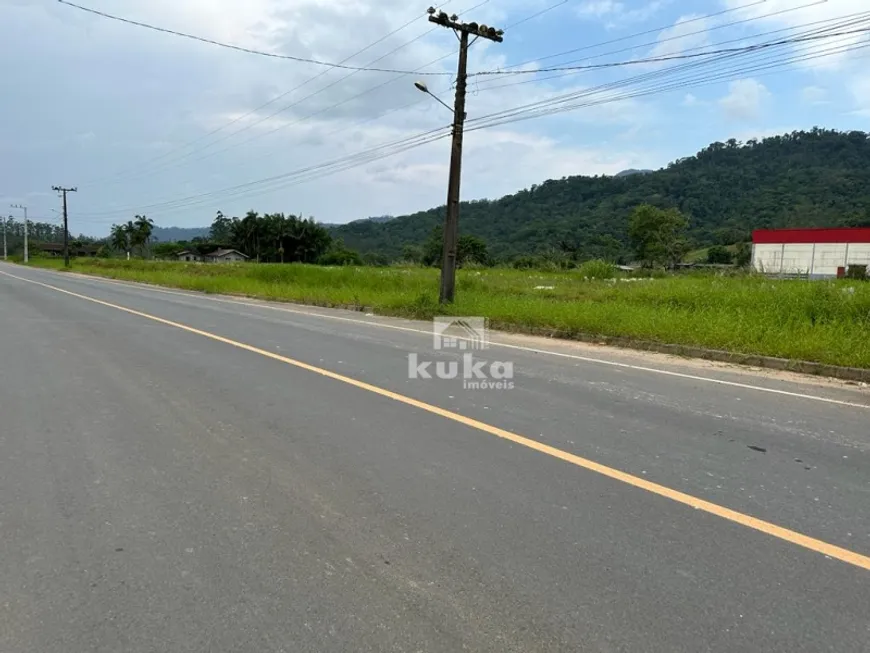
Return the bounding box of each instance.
[6,272,870,571]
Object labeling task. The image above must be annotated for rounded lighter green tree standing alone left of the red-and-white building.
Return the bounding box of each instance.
[628,204,689,268]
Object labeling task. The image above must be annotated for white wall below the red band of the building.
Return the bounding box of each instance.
[752,243,870,277]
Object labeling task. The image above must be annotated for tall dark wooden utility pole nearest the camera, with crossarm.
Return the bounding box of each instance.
[418,7,504,304]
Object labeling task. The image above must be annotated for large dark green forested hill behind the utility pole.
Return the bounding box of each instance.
[331,129,870,259]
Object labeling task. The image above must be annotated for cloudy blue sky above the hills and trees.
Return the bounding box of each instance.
[0,0,870,236]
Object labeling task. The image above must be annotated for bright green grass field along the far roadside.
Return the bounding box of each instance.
[23,259,870,368]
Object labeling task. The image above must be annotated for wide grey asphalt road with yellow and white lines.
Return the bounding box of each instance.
[0,264,870,653]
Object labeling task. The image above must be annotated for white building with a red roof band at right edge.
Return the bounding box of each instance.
[752,227,870,279]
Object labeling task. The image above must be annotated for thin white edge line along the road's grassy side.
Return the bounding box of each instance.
[8,268,870,410]
